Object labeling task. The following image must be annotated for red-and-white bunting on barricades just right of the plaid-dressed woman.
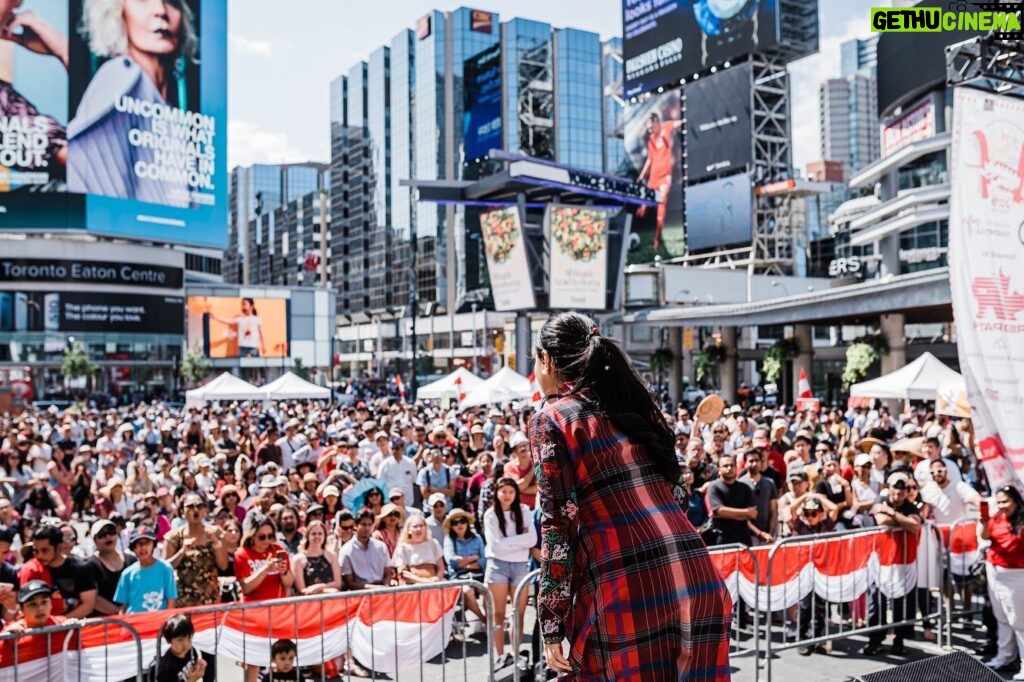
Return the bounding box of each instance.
[711,530,927,611]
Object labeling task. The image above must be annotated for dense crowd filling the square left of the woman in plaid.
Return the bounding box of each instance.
[0,400,548,675]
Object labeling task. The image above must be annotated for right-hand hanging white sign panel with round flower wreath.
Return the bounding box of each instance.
[545,205,610,310]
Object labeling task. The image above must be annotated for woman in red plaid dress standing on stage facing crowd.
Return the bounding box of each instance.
[529,312,732,682]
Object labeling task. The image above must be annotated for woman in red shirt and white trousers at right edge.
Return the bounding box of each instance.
[978,485,1024,680]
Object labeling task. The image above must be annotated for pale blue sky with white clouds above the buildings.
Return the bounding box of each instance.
[228,0,889,173]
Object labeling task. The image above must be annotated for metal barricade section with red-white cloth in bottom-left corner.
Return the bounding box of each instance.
[0,619,143,682]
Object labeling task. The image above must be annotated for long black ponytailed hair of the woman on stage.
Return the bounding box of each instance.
[538,312,680,484]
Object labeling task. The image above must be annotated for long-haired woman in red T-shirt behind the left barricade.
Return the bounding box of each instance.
[234,514,295,682]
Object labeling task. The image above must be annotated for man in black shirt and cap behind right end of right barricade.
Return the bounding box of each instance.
[862,471,922,656]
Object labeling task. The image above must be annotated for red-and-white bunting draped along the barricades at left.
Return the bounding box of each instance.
[0,588,461,682]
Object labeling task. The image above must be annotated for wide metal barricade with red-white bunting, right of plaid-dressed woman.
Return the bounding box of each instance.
[758,523,945,682]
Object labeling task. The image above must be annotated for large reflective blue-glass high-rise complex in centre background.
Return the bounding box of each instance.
[331,7,623,324]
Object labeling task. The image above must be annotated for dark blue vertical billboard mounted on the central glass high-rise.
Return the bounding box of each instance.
[463,44,502,160]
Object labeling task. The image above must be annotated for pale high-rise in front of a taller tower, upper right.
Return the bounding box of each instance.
[818,75,881,176]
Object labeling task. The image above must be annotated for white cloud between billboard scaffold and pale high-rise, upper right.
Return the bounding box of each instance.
[790,15,868,171]
